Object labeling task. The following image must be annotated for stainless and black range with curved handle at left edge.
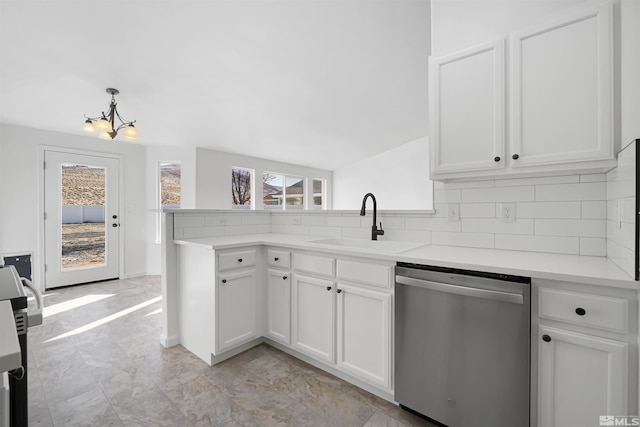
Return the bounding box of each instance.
[0,265,42,427]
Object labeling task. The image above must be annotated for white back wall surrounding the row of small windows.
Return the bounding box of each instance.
[196,148,332,210]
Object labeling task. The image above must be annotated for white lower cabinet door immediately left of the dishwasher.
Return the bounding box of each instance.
[337,283,391,390]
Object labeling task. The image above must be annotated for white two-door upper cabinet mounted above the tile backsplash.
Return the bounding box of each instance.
[430,2,615,180]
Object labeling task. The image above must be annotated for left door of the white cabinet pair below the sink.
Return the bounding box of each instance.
[293,275,335,363]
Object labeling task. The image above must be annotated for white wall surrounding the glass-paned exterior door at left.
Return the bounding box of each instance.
[0,124,146,288]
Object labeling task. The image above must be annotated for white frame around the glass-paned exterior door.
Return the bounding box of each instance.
[37,145,127,292]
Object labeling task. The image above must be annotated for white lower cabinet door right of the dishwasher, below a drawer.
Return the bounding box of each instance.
[538,326,629,427]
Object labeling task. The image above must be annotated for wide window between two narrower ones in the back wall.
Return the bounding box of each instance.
[262,172,305,210]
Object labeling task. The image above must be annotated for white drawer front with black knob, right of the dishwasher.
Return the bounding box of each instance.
[538,288,629,333]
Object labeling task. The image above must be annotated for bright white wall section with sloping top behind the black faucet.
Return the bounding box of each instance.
[333,137,433,210]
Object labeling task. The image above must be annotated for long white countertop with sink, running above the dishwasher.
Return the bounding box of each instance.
[174,233,640,290]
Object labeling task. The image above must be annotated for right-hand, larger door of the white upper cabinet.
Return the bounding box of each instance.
[510,3,614,168]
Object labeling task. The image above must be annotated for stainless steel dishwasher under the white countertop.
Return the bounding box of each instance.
[395,263,531,427]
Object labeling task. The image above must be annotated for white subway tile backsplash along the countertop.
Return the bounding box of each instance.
[175,157,635,270]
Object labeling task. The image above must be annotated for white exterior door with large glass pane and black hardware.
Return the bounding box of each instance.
[44,151,120,289]
